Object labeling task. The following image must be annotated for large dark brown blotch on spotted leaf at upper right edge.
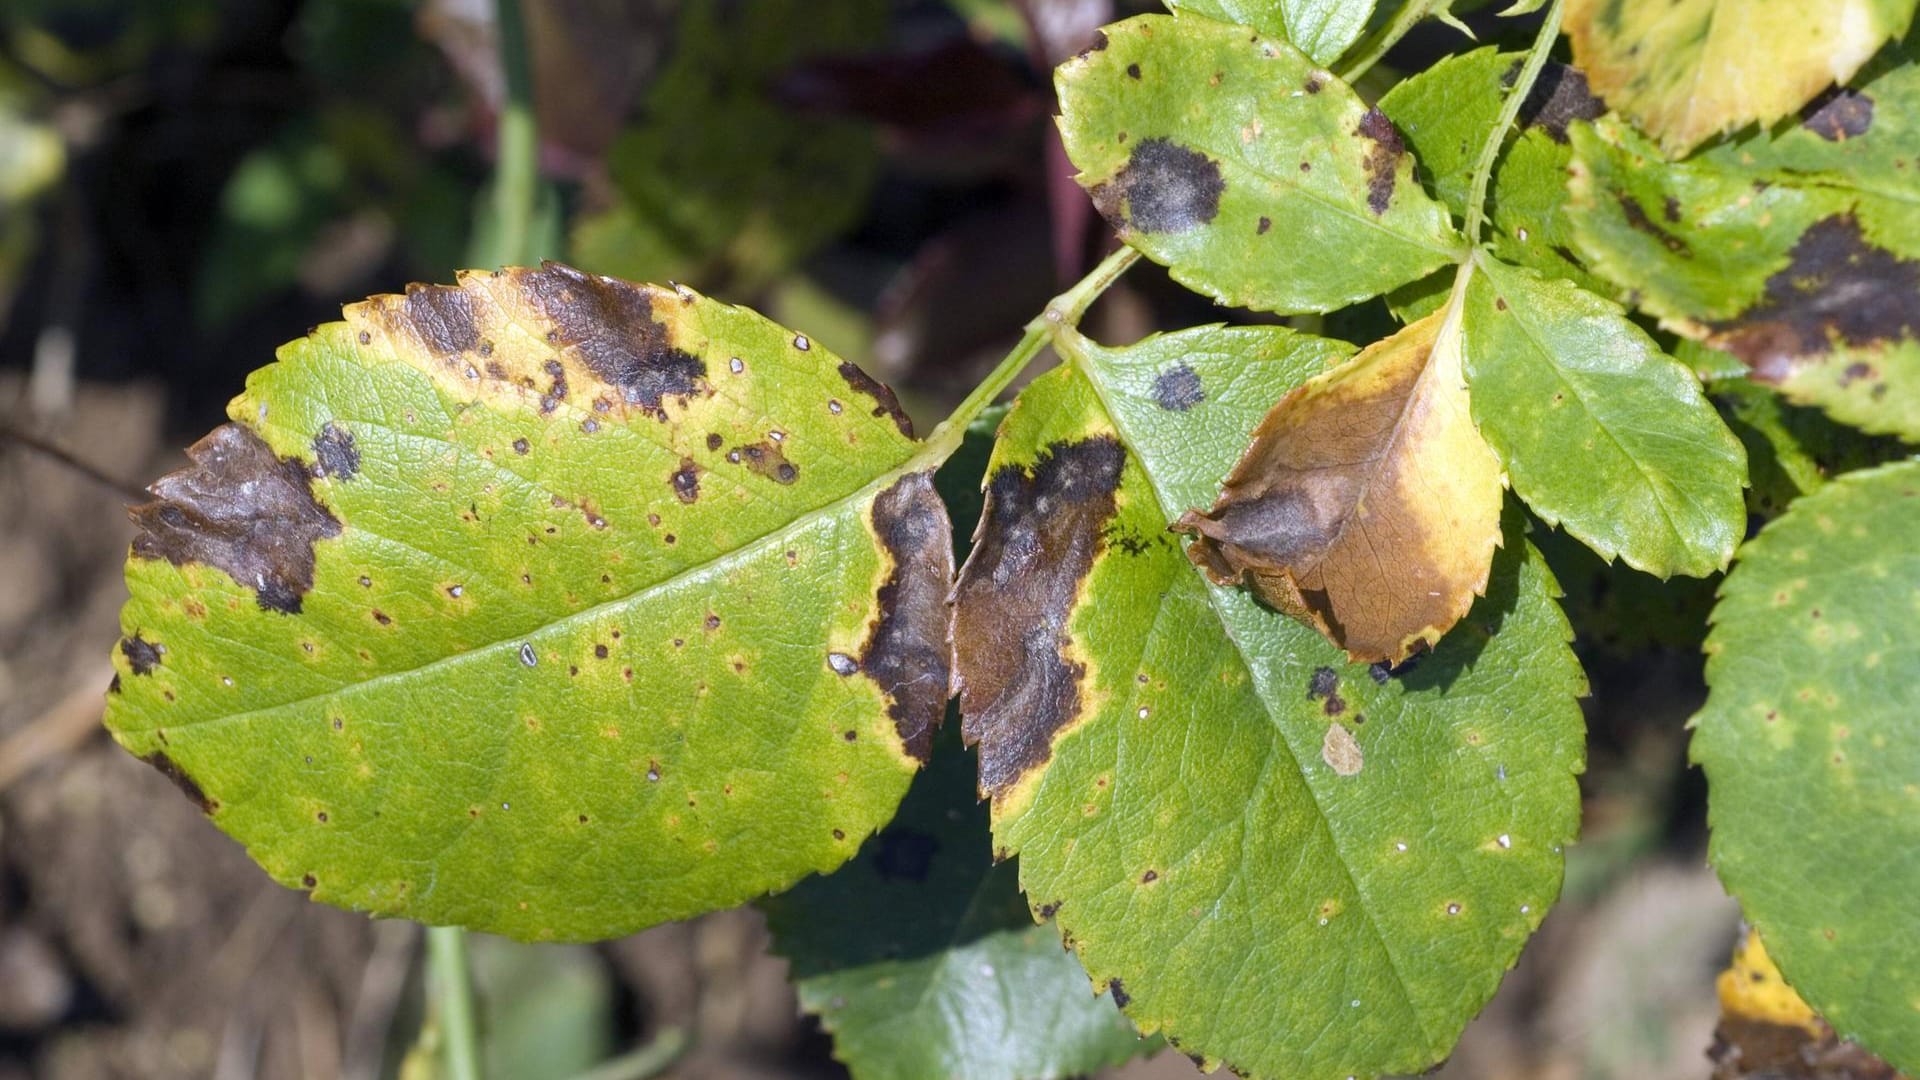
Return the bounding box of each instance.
[1711,213,1920,382]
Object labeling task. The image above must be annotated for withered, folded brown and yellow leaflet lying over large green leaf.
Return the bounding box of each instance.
[1173,303,1501,663]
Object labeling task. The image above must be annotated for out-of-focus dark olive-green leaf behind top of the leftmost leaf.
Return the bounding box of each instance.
[572,0,887,290]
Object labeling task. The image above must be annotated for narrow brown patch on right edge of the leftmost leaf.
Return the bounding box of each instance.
[860,473,954,761]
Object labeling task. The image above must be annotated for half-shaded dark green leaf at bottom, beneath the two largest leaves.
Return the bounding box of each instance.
[762,718,1160,1080]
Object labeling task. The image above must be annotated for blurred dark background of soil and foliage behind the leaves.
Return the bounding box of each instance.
[0,0,1738,1080]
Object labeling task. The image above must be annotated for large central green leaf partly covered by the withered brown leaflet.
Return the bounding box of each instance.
[954,327,1584,1078]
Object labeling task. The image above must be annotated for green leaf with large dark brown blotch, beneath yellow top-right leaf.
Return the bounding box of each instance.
[1569,54,1920,438]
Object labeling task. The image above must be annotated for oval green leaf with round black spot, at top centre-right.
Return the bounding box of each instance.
[1054,15,1459,311]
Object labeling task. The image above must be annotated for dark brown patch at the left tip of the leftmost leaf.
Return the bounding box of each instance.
[129,425,340,615]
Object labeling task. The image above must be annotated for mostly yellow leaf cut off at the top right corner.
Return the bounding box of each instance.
[1565,0,1914,158]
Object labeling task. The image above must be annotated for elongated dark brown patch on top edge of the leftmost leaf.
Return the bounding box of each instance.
[513,263,707,411]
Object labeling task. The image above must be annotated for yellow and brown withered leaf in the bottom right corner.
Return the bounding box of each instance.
[1707,930,1899,1080]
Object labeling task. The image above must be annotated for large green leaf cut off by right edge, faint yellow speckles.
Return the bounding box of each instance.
[1692,461,1920,1072]
